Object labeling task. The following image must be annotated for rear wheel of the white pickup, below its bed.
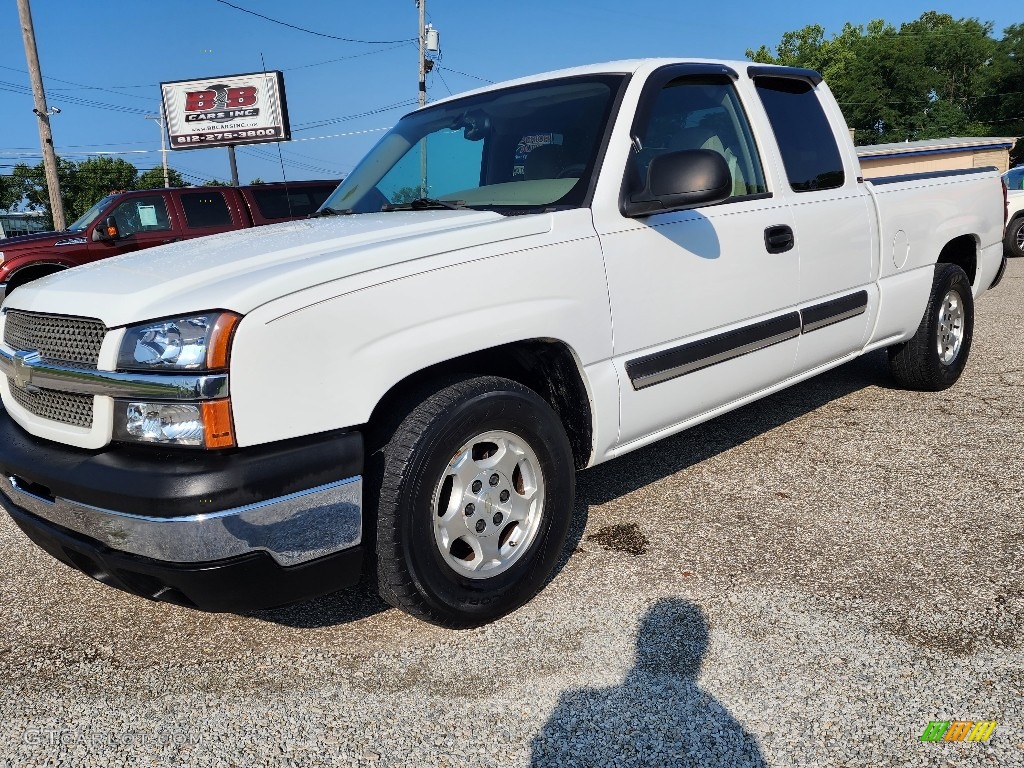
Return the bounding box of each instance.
[889,264,974,392]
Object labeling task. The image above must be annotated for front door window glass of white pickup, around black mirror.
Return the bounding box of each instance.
[632,77,767,200]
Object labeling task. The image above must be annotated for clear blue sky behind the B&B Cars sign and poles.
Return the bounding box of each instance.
[0,0,1024,183]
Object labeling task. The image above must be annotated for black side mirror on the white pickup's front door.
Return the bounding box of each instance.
[623,150,732,218]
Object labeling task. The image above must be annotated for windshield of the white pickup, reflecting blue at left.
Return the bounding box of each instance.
[321,75,625,213]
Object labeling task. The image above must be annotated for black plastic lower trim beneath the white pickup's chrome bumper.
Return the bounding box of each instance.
[7,507,364,612]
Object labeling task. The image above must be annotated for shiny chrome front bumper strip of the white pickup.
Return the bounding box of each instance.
[0,475,362,566]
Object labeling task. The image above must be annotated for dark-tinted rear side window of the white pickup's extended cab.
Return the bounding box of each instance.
[754,77,846,191]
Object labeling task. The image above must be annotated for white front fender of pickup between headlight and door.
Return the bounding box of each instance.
[230,211,611,445]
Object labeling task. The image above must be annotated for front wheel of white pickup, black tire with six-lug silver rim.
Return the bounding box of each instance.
[377,377,575,628]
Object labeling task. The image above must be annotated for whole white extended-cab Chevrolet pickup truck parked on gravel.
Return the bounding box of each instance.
[0,59,1005,627]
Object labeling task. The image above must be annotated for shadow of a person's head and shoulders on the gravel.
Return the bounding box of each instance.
[531,598,767,768]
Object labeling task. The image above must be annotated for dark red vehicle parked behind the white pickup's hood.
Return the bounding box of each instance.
[0,180,340,301]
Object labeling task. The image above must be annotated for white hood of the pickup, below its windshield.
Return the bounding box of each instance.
[4,210,551,328]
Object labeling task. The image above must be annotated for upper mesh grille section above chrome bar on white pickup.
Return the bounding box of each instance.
[3,309,106,368]
